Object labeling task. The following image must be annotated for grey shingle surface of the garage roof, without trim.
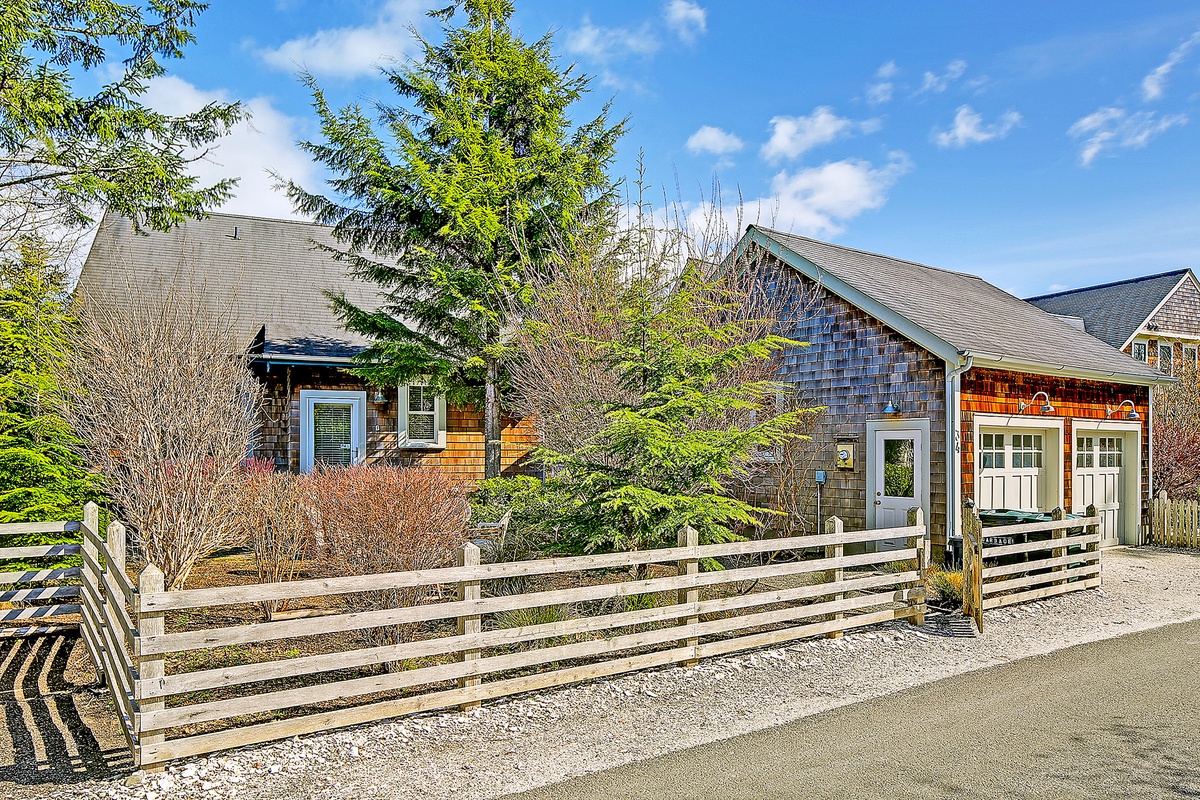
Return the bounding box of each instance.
[754,225,1157,378]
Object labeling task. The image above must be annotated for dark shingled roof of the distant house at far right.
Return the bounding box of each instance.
[1027,269,1192,350]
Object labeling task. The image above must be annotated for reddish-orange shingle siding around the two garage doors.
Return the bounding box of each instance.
[960,368,1150,525]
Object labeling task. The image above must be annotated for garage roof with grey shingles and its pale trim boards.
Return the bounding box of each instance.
[743,225,1159,385]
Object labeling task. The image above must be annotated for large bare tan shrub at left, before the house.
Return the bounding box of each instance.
[62,288,263,589]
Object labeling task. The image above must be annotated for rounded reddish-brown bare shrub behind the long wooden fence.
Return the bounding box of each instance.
[304,465,470,646]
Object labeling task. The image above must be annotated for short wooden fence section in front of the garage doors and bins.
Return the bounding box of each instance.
[962,506,1100,633]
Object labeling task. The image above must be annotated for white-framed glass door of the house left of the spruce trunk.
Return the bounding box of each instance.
[300,389,367,473]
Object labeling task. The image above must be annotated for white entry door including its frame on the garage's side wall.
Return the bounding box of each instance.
[866,420,929,549]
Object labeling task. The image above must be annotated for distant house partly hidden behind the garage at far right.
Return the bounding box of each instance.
[1028,270,1200,375]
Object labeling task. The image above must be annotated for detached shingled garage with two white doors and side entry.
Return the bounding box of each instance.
[739,225,1163,561]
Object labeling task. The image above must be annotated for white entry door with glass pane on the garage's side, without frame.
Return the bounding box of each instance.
[870,428,925,549]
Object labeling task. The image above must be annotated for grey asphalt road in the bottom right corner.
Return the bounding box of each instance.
[512,622,1200,800]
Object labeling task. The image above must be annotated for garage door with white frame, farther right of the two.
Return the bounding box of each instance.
[1072,421,1141,547]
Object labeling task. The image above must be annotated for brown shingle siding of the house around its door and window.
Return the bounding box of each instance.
[253,365,540,482]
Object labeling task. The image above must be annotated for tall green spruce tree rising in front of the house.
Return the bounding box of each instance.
[288,0,624,477]
